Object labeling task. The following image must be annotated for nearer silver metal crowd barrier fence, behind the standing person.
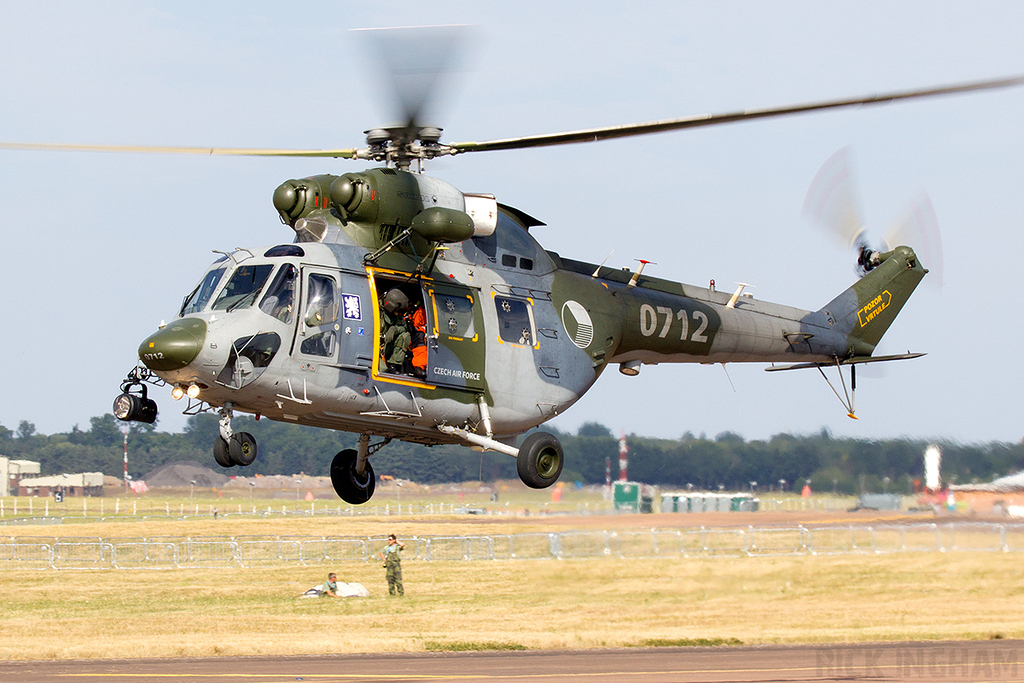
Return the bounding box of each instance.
[0,522,1024,570]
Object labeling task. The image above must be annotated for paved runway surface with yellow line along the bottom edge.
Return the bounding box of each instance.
[0,640,1024,683]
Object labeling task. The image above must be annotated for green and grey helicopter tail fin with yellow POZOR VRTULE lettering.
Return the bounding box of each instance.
[820,247,928,356]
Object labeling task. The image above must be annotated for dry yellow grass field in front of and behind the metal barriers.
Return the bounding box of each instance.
[0,516,1024,659]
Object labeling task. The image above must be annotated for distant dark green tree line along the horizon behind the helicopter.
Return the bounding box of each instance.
[0,414,1024,495]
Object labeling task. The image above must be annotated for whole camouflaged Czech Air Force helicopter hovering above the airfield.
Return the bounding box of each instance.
[12,45,1024,505]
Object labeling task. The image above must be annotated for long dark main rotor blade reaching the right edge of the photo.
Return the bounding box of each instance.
[450,76,1024,154]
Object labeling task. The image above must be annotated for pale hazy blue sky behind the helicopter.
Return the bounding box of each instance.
[0,1,1024,441]
